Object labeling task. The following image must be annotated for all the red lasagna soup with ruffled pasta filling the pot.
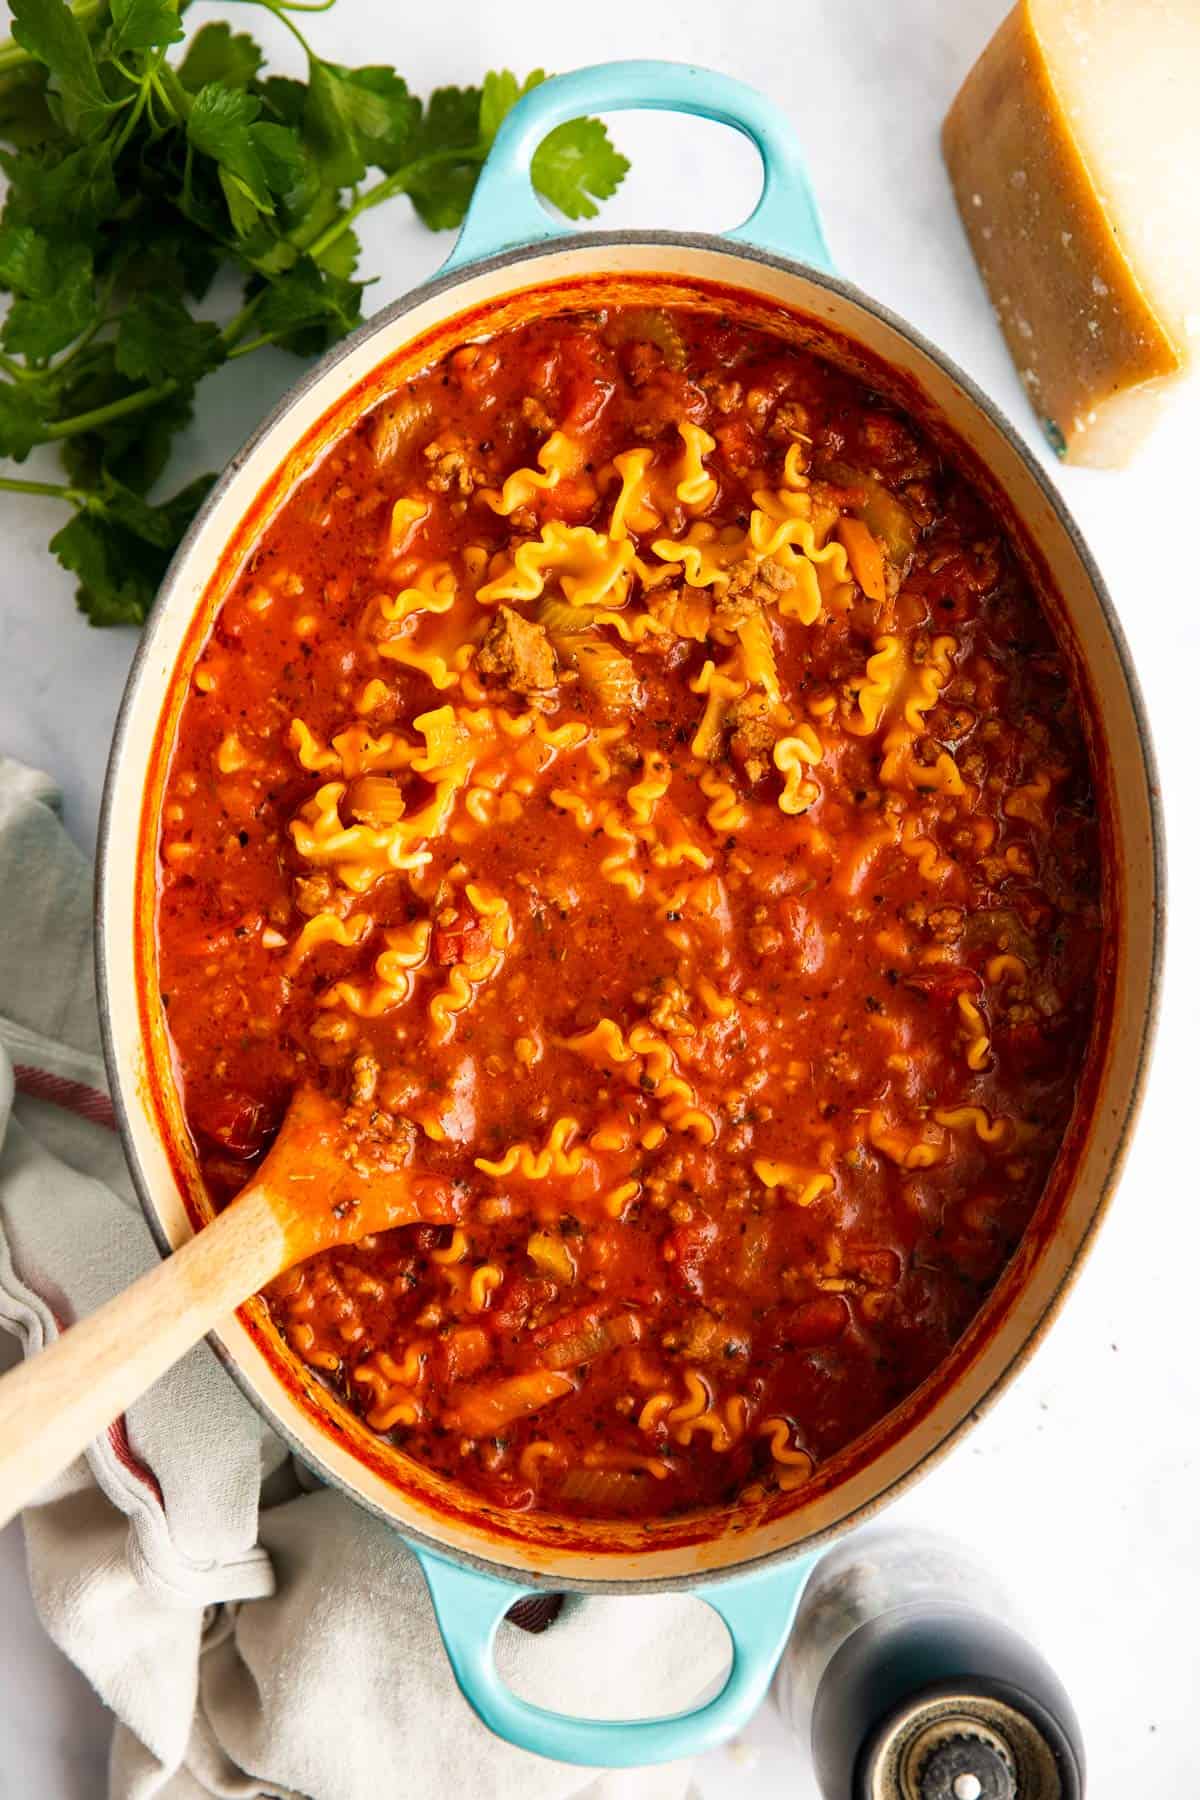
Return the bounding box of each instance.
[157,301,1103,1517]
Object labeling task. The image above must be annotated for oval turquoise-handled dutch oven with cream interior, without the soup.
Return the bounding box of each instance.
[97,63,1162,1766]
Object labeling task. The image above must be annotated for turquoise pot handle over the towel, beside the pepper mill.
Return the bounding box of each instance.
[408,1543,817,1769]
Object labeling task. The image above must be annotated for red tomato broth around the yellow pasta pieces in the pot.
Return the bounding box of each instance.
[150,295,1101,1517]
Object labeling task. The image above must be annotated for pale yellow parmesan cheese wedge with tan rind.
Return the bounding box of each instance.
[943,0,1200,468]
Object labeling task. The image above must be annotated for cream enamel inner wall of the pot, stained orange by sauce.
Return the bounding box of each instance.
[99,238,1160,1588]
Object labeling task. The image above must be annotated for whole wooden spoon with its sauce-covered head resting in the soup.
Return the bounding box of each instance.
[0,1087,462,1525]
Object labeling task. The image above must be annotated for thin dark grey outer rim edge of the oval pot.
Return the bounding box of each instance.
[94,230,1166,1595]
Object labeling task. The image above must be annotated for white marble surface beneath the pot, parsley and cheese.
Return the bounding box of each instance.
[0,0,1200,1800]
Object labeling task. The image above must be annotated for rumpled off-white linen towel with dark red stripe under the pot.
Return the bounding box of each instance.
[0,758,727,1800]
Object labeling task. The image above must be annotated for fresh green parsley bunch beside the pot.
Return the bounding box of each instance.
[0,0,628,625]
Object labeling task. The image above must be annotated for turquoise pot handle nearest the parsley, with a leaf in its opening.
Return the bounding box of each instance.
[444,61,833,272]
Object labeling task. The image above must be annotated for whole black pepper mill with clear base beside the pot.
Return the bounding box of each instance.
[777,1532,1083,1800]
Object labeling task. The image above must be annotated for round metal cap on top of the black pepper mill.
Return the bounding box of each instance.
[858,1688,1072,1800]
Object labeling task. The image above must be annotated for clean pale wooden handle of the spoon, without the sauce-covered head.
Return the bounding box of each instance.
[0,1188,288,1526]
